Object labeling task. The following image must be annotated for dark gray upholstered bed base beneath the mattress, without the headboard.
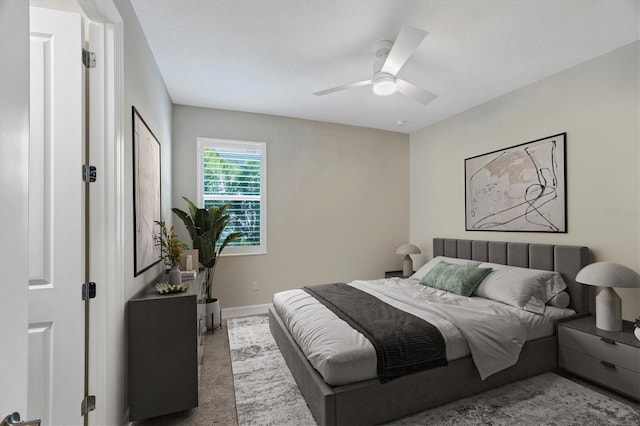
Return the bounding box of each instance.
[269,307,557,425]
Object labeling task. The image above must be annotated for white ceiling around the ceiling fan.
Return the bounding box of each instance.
[132,0,640,133]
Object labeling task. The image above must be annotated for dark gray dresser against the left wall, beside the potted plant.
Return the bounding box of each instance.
[127,274,206,421]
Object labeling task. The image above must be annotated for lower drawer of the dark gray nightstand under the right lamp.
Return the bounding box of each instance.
[558,346,640,399]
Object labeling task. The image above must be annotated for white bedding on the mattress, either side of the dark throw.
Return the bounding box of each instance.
[273,278,574,386]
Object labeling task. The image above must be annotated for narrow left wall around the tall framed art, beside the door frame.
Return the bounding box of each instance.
[111,0,172,424]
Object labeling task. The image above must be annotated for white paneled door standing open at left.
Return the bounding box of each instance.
[27,8,84,425]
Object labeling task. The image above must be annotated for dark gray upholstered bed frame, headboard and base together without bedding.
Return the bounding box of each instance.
[269,238,588,425]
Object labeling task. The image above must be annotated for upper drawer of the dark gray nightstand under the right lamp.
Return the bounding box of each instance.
[558,327,640,373]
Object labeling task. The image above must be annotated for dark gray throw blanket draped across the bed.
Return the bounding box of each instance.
[303,283,447,383]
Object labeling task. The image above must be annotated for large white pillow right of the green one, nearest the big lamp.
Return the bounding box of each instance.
[474,263,567,314]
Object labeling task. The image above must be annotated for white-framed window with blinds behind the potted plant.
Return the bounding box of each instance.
[198,138,267,254]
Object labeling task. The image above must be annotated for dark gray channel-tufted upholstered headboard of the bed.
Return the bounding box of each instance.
[433,238,589,312]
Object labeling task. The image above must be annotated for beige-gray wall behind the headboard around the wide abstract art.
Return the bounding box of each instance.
[410,42,640,320]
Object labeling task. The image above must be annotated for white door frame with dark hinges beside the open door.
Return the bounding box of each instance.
[77,0,128,424]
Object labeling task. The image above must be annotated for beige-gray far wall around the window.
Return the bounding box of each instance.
[173,105,409,308]
